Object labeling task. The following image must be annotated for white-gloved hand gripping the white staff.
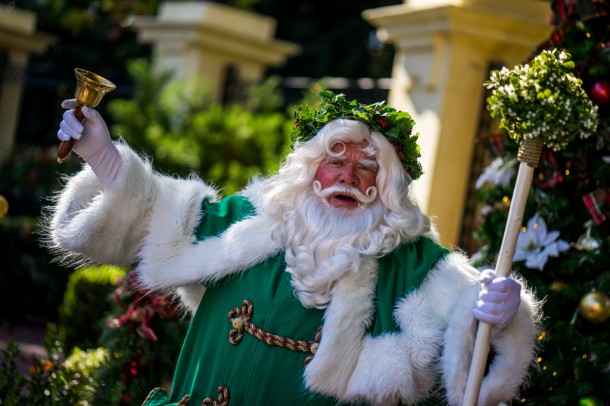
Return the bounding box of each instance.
[472,269,521,329]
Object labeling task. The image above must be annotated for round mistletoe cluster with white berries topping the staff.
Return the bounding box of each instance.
[484,49,599,151]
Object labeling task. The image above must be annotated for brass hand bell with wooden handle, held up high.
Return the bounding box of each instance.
[57,68,116,163]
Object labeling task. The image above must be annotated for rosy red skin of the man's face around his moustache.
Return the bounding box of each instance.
[315,142,378,210]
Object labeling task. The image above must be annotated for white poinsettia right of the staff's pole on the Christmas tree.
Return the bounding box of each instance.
[513,213,570,271]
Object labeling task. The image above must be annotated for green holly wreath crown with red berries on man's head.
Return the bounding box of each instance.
[290,90,423,180]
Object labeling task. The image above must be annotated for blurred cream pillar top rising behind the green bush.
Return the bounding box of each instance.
[133,1,299,100]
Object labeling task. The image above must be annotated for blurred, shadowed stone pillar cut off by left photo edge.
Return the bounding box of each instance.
[0,5,55,162]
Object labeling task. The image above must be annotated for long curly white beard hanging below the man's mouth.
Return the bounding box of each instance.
[278,191,386,308]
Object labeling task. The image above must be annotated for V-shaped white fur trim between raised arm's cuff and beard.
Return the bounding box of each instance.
[138,188,280,289]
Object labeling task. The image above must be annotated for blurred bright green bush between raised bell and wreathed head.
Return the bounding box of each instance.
[108,60,293,193]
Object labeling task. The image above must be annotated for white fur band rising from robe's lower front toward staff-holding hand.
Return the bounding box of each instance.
[348,254,474,405]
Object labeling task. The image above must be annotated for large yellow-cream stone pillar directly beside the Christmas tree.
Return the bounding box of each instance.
[363,0,552,245]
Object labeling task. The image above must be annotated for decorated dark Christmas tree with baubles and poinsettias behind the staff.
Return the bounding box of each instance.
[475,0,610,406]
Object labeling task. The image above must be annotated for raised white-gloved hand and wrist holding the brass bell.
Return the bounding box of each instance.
[57,99,123,188]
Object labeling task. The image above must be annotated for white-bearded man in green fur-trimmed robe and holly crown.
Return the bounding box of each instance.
[49,93,539,406]
